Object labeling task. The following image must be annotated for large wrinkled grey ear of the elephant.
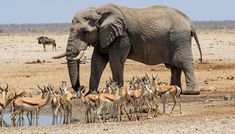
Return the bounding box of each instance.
[96,5,126,48]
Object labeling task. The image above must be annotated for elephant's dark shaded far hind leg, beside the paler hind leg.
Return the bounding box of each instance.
[171,67,182,89]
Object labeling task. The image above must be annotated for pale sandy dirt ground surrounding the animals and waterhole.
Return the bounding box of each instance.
[0,30,235,134]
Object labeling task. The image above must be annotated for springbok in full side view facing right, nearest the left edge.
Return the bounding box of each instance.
[11,86,52,126]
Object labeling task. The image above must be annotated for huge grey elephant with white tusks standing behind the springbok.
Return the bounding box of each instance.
[52,4,202,95]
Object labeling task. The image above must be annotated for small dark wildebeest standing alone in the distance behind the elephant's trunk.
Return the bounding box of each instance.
[37,36,56,52]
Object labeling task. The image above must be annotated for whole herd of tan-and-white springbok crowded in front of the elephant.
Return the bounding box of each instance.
[0,74,181,126]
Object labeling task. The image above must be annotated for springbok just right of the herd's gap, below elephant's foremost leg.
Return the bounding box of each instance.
[80,86,98,123]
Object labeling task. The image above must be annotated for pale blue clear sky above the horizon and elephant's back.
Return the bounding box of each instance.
[0,0,235,24]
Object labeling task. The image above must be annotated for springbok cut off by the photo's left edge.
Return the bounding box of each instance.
[0,84,8,126]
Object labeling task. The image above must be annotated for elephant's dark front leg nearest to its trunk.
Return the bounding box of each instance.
[88,48,108,94]
